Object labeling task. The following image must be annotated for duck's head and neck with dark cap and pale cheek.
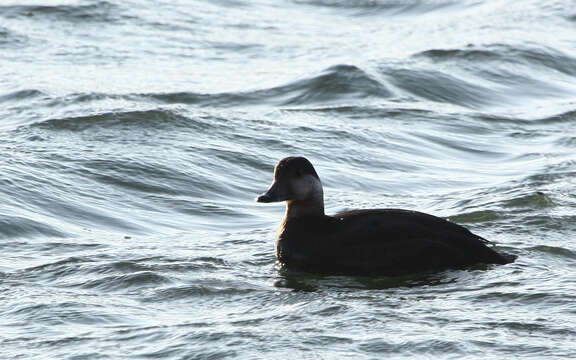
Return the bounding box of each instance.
[256,157,324,215]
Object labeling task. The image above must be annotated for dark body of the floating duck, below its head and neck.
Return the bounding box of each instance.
[276,209,511,275]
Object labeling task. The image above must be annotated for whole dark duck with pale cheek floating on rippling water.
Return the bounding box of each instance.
[256,156,517,276]
